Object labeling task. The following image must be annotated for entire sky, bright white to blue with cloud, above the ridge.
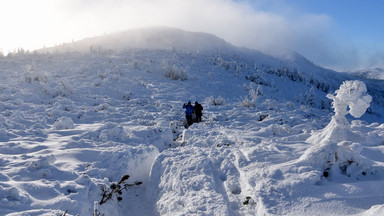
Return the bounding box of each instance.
[0,0,384,71]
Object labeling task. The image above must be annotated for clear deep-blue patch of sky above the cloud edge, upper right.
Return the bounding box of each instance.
[280,0,384,48]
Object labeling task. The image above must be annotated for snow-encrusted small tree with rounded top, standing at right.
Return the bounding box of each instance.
[300,80,372,177]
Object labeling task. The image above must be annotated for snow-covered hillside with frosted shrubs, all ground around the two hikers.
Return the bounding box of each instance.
[0,27,384,216]
